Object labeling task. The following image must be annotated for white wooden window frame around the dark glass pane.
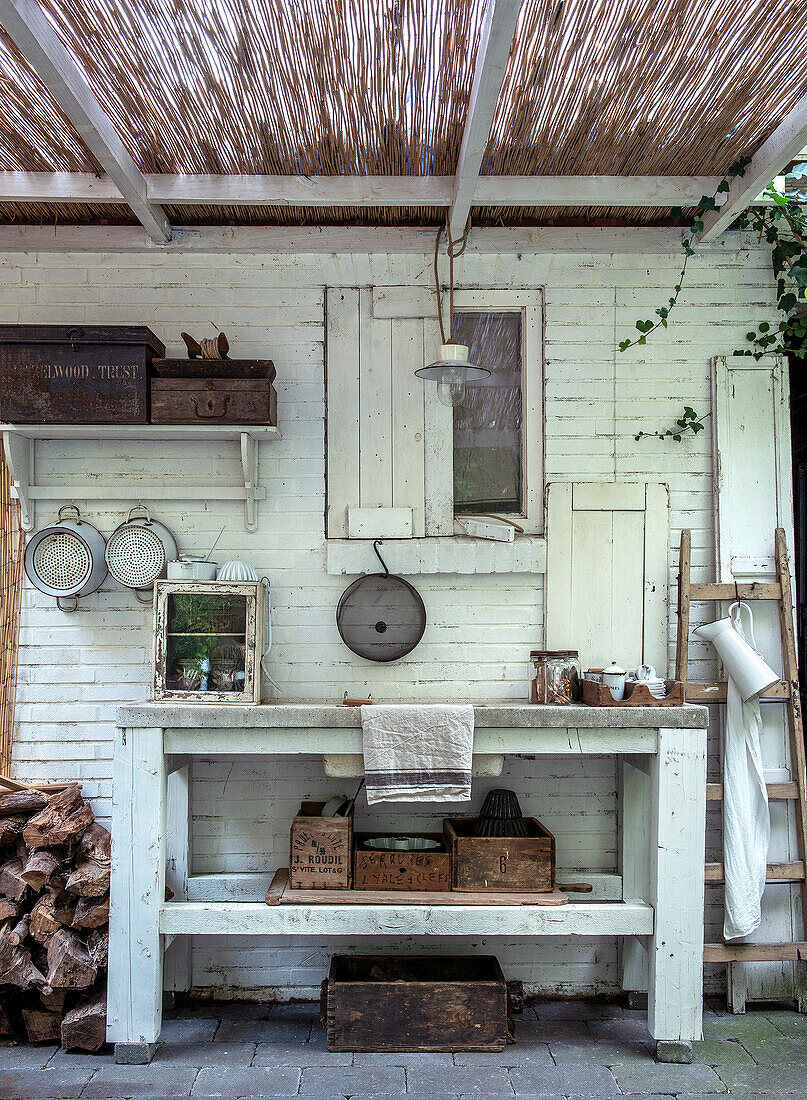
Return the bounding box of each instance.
[423,289,545,536]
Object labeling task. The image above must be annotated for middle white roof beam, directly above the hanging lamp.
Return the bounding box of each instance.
[449,0,521,238]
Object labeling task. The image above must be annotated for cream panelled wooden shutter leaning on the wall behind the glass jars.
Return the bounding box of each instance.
[545,482,670,677]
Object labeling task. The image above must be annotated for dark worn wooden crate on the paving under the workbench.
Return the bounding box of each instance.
[322,955,508,1053]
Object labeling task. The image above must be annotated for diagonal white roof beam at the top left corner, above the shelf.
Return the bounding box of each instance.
[0,0,172,243]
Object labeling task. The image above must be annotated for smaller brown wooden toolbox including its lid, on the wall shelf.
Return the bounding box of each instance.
[151,359,277,427]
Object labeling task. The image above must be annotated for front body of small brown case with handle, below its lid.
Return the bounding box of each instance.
[152,377,277,427]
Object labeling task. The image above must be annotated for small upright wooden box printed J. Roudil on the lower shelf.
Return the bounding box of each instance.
[289,802,353,890]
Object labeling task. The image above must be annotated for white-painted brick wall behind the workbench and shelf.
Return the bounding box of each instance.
[0,235,774,996]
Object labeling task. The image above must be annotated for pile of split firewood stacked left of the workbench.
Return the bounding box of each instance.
[0,784,111,1051]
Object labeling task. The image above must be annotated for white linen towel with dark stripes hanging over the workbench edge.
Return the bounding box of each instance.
[362,703,474,805]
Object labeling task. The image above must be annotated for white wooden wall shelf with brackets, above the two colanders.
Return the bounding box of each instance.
[0,424,283,531]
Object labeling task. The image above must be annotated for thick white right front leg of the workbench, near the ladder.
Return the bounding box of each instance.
[649,729,706,1062]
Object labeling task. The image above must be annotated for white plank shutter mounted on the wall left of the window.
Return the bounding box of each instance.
[325,287,425,538]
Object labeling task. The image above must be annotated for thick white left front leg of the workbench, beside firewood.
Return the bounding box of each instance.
[107,728,166,1064]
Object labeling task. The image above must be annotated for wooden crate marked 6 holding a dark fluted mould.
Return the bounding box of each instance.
[443,817,555,893]
